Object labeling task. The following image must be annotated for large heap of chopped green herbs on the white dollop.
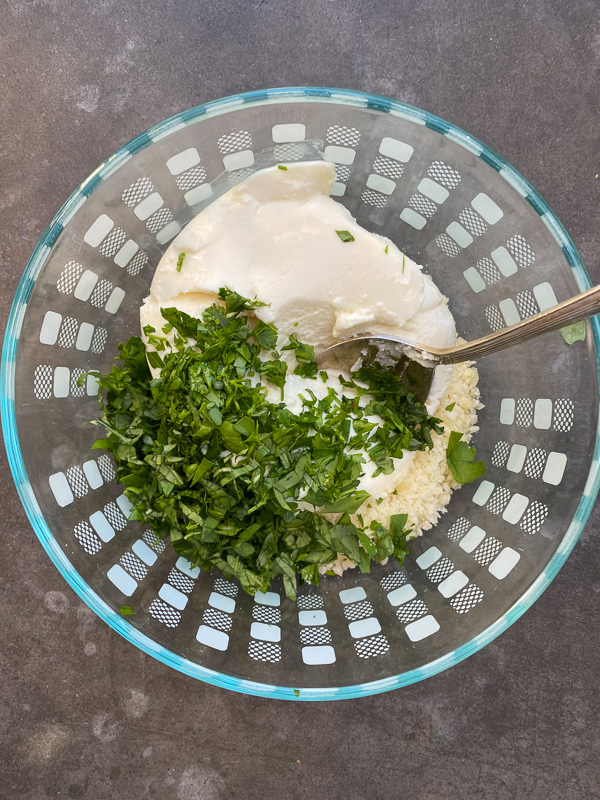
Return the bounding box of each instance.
[93,289,452,599]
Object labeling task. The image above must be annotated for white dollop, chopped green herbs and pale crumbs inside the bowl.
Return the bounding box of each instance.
[89,161,485,598]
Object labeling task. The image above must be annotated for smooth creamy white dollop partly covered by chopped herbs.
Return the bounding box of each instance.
[140,161,456,498]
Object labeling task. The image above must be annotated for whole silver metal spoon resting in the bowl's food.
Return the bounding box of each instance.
[315,286,600,403]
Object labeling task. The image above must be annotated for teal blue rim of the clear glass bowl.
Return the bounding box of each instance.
[0,86,600,701]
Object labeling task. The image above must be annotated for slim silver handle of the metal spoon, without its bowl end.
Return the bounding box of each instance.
[432,286,600,364]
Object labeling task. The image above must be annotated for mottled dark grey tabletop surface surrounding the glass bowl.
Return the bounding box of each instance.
[0,0,600,800]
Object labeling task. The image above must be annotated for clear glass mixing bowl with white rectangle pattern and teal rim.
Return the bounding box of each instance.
[2,88,599,700]
